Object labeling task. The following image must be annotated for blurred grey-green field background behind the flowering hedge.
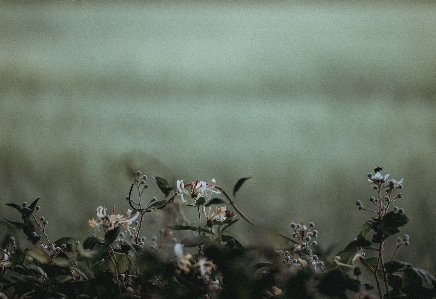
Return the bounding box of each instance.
[0,2,436,270]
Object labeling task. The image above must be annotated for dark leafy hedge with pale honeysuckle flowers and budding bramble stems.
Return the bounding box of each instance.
[0,167,436,299]
